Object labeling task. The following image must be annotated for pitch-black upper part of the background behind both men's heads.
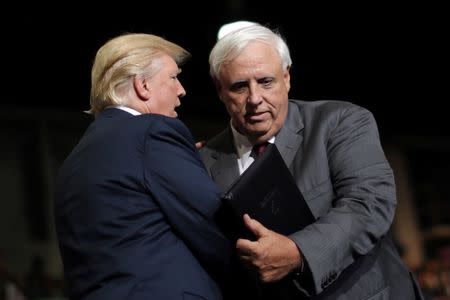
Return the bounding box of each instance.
[2,0,448,134]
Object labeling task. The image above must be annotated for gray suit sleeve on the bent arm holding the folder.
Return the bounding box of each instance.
[291,106,396,293]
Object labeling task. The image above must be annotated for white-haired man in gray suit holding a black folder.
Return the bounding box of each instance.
[201,23,422,300]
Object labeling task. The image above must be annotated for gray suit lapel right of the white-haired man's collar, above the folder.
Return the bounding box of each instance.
[275,103,303,167]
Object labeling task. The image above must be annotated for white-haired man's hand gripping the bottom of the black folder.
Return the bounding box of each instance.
[236,214,302,282]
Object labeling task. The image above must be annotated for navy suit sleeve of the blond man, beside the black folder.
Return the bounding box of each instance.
[144,118,231,277]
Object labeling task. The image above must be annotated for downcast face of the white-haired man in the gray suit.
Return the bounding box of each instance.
[216,42,290,143]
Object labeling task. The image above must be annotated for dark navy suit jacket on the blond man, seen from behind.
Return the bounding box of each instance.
[55,108,231,300]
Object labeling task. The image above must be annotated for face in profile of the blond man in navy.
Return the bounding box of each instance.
[149,55,186,117]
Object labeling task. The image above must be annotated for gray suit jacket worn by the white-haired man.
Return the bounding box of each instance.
[201,100,420,300]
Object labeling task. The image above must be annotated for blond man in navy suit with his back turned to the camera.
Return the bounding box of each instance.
[55,34,231,300]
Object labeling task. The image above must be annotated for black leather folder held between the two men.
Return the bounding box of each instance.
[218,144,315,239]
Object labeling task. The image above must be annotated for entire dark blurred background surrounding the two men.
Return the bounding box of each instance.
[0,0,450,299]
